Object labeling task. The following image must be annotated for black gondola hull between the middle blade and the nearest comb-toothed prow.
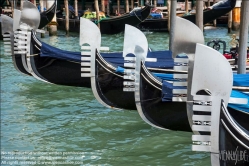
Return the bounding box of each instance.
[140,63,192,131]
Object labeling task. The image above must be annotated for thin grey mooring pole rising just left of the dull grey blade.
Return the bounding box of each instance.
[169,0,177,50]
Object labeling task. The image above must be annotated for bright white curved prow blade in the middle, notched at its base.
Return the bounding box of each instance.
[123,24,148,59]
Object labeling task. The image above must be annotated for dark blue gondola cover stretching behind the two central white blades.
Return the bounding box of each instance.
[40,42,174,69]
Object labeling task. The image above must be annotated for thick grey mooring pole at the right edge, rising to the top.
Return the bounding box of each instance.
[238,0,249,74]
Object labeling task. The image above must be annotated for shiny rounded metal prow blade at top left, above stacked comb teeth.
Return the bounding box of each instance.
[20,1,41,30]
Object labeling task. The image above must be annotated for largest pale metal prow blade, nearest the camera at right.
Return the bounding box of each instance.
[191,44,233,105]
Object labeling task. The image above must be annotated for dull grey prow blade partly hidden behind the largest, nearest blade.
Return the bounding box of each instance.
[171,17,204,58]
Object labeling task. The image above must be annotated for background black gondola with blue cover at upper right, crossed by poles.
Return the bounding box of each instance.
[138,0,236,32]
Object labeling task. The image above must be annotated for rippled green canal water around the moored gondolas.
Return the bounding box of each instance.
[0,28,247,166]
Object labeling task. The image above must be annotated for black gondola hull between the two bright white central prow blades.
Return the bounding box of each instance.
[95,51,136,110]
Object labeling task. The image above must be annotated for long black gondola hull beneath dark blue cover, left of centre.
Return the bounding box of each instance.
[30,31,91,87]
